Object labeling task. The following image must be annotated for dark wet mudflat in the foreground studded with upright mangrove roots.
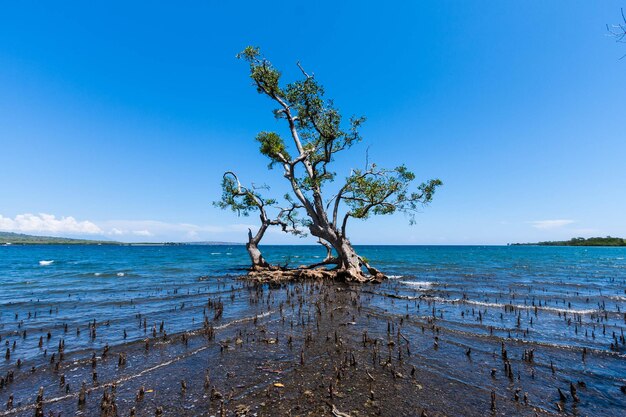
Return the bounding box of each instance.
[0,281,626,416]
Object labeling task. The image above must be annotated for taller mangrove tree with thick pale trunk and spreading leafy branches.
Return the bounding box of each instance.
[219,47,442,282]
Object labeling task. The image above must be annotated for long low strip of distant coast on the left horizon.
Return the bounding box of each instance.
[0,232,242,246]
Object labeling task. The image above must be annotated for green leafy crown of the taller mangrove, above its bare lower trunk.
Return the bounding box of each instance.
[235,46,442,236]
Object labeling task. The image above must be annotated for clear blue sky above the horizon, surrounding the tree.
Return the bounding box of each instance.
[0,0,626,244]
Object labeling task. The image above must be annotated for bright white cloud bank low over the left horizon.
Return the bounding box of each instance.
[0,213,103,234]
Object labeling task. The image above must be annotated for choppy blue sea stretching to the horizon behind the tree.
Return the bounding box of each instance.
[0,245,626,359]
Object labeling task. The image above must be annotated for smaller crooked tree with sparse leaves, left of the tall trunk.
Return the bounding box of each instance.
[213,171,303,270]
